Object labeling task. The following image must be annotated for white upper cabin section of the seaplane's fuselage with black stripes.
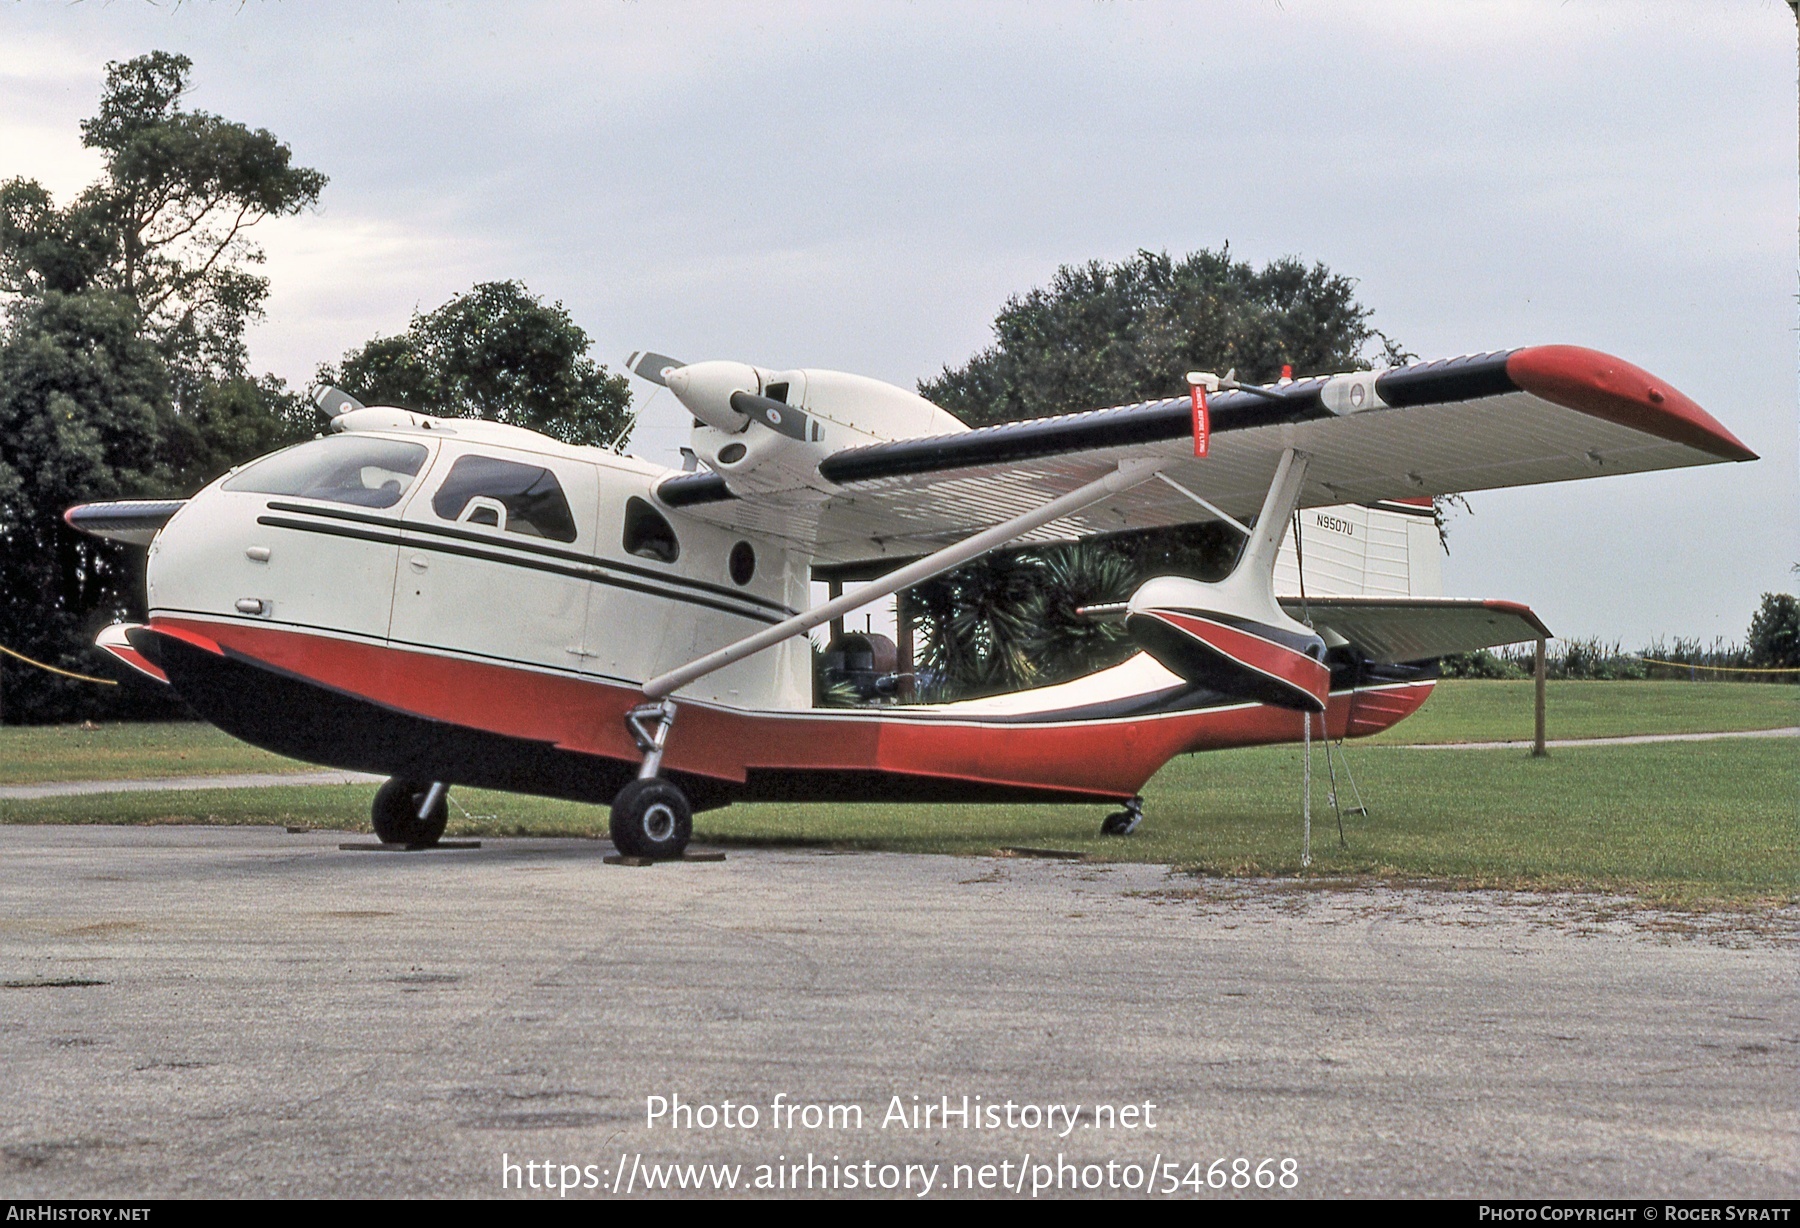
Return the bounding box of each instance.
[149,420,812,708]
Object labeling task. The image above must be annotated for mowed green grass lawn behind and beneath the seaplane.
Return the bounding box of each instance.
[0,682,1800,904]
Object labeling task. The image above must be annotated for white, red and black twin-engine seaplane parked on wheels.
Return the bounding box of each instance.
[67,346,1755,857]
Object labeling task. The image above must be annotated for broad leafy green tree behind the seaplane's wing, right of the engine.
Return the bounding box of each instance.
[909,247,1411,699]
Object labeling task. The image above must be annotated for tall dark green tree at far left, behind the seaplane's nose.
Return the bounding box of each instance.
[0,52,326,720]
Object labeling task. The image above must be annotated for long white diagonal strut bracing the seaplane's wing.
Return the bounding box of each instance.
[644,461,1168,700]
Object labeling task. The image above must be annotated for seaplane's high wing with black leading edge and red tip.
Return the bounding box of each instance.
[657,346,1757,565]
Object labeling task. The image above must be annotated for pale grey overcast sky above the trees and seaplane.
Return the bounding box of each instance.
[0,0,1800,648]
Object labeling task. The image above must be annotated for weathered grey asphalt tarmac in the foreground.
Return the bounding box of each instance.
[0,826,1800,1197]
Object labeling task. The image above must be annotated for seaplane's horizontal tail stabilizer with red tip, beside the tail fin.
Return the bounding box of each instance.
[1282,596,1550,664]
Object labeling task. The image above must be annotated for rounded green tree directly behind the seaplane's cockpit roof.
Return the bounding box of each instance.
[319,281,635,447]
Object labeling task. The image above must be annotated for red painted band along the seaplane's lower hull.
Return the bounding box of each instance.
[149,618,1433,801]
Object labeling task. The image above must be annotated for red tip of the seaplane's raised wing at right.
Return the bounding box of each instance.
[1507,346,1757,461]
